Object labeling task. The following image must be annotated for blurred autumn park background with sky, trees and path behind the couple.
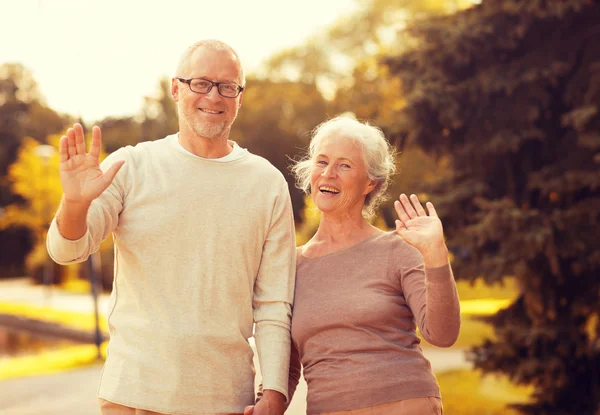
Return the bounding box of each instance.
[0,0,600,415]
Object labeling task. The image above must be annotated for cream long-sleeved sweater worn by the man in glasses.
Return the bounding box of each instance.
[47,135,295,415]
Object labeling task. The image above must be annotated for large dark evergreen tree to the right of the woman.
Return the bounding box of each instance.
[384,0,600,414]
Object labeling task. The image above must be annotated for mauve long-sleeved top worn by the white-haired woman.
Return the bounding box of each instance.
[289,232,460,414]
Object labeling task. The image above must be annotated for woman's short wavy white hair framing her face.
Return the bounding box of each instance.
[291,115,396,217]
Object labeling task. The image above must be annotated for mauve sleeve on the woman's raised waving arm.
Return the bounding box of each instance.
[396,247,460,347]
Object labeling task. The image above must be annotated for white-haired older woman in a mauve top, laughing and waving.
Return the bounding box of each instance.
[247,117,460,415]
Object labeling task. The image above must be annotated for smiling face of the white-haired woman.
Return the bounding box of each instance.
[310,133,376,218]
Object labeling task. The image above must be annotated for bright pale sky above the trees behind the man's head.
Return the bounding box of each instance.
[0,0,356,121]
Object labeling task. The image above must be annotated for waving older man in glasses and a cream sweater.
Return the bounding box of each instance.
[47,40,295,415]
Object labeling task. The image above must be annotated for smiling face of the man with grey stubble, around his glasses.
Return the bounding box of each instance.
[171,46,243,139]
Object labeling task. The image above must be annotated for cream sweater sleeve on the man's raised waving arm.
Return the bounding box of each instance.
[46,149,131,265]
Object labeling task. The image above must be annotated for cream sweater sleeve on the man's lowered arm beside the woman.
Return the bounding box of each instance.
[253,176,296,401]
